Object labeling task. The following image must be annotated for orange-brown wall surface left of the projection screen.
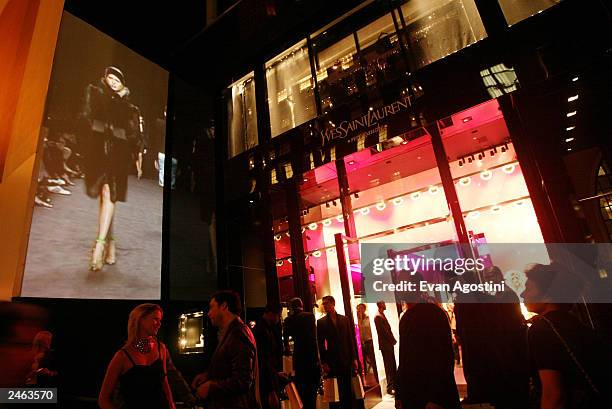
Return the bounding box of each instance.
[0,0,64,300]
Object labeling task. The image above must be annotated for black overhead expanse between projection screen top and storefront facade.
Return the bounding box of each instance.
[65,0,364,91]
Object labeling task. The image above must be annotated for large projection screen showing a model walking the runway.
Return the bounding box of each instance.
[21,12,168,300]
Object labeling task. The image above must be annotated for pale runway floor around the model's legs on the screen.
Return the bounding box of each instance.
[21,176,163,300]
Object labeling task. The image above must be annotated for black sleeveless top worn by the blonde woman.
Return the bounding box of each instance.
[119,343,169,409]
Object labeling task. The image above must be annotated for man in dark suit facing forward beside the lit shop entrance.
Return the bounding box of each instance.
[317,295,358,408]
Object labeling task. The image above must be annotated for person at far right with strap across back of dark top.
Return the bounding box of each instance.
[522,264,612,409]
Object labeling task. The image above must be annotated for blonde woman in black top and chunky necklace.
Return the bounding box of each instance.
[98,304,176,409]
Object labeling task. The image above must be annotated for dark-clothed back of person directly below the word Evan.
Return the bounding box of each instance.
[396,284,460,409]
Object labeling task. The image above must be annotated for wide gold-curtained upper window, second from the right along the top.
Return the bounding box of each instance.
[401,0,486,69]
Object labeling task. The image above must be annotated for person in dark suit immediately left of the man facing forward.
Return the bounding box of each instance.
[283,297,321,409]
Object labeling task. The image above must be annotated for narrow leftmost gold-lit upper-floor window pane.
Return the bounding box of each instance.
[227,72,257,158]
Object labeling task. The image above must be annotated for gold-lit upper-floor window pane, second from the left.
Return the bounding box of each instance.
[266,40,317,137]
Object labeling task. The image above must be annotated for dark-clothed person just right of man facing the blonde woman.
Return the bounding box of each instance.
[254,303,283,409]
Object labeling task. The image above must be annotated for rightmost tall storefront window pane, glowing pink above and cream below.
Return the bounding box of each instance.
[438,100,550,285]
